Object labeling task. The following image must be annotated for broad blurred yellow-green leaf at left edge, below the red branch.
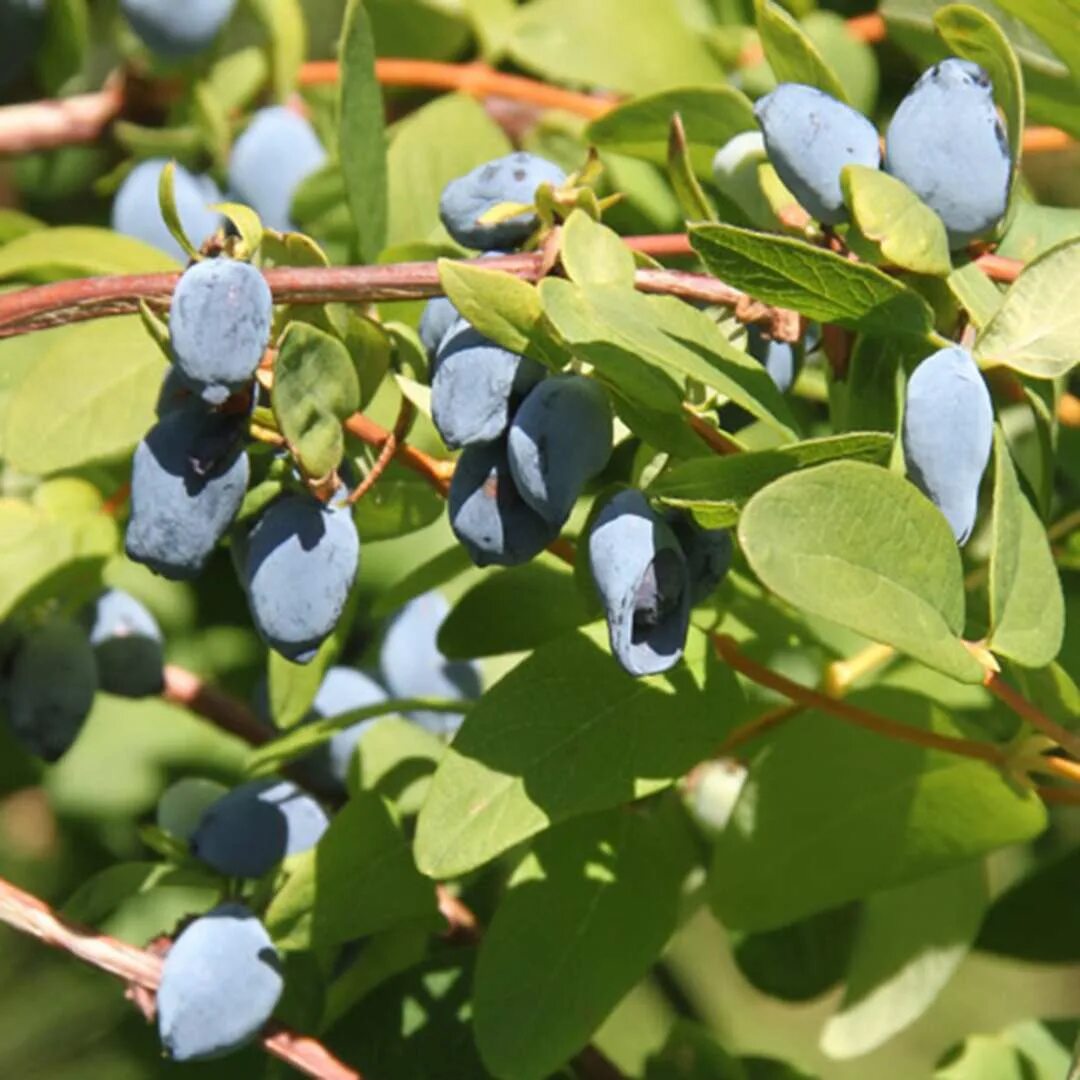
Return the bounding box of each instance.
[3,315,165,475]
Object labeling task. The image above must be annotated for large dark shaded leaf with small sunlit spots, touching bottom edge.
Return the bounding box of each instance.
[473,804,693,1080]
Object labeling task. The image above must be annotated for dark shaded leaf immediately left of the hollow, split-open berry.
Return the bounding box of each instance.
[438,561,592,659]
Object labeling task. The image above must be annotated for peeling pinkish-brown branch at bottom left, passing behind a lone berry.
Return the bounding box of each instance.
[0,878,363,1080]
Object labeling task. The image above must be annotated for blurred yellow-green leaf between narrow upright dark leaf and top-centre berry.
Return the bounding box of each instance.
[384,94,512,244]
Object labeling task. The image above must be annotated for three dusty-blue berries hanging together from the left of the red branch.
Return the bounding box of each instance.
[125,250,360,663]
